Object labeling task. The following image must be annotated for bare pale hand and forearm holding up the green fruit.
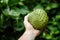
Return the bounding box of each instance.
[18,15,40,40]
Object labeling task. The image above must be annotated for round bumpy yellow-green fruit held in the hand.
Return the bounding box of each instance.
[28,9,48,30]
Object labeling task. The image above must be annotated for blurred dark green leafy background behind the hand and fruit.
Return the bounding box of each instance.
[0,0,60,40]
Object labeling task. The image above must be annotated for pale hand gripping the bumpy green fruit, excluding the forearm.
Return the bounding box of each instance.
[24,15,40,36]
